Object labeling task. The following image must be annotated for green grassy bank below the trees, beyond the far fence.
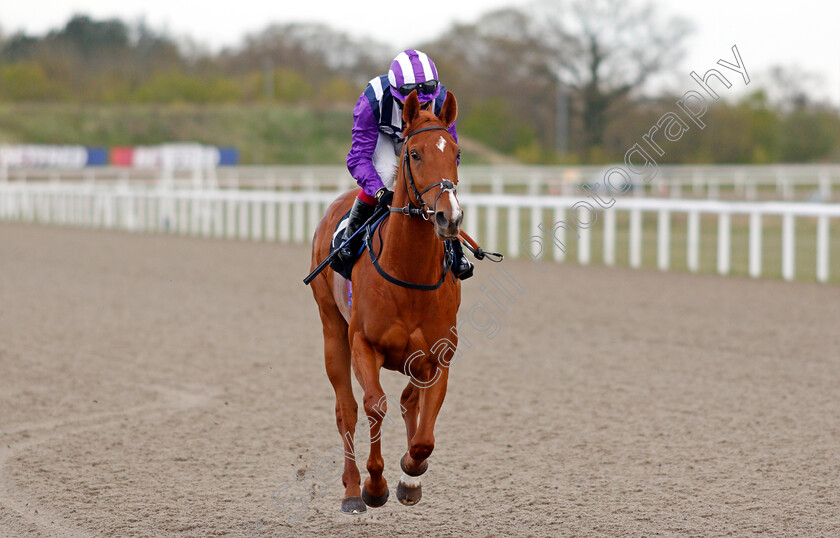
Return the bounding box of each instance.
[0,104,498,165]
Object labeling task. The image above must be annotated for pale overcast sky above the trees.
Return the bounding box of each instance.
[0,0,840,105]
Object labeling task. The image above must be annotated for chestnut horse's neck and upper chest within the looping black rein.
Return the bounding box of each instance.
[382,184,443,276]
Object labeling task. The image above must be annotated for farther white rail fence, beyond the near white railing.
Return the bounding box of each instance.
[0,164,840,202]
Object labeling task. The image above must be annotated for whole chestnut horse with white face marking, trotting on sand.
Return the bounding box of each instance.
[312,92,463,513]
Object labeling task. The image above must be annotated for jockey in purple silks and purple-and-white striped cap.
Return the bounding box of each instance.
[338,50,473,280]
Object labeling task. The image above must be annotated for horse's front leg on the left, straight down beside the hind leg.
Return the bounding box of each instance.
[353,334,388,508]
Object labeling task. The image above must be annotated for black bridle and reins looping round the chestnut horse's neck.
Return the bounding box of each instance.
[365,126,455,291]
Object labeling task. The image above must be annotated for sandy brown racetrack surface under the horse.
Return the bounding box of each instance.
[0,221,840,536]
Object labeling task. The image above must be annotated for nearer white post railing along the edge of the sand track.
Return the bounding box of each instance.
[0,183,840,282]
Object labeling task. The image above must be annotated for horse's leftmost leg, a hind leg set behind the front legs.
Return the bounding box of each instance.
[319,305,367,514]
